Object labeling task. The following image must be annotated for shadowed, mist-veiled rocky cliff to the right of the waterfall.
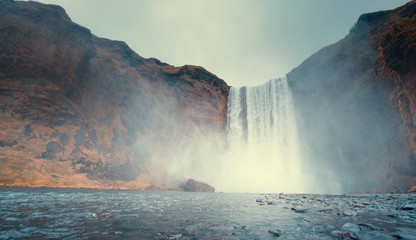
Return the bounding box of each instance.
[287,1,416,191]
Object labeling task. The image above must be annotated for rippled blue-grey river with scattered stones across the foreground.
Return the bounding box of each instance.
[0,187,416,239]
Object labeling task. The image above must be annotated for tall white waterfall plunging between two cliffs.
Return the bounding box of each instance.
[219,78,322,193]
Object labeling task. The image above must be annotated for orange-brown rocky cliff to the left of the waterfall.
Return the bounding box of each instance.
[0,0,229,189]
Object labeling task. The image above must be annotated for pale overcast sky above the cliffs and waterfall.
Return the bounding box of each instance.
[30,0,408,86]
